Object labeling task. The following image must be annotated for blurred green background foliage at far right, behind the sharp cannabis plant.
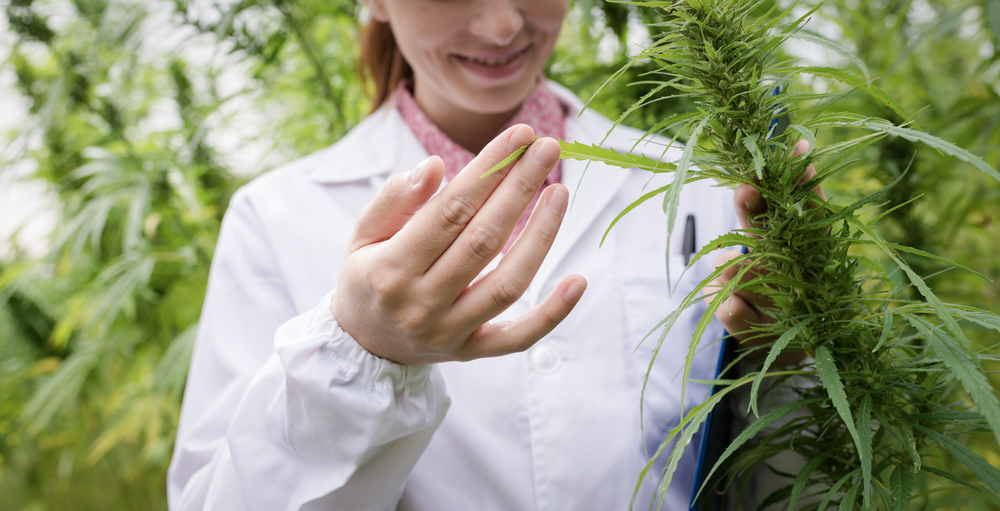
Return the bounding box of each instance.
[819,0,1000,510]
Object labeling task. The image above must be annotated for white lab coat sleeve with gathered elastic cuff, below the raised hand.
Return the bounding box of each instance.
[168,194,449,510]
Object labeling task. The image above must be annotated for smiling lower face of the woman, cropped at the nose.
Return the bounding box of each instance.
[368,0,568,115]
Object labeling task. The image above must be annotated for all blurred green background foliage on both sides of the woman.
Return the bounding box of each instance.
[0,0,1000,510]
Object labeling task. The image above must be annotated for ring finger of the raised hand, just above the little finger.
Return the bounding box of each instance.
[451,184,569,326]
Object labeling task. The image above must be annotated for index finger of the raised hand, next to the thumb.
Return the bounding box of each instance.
[388,125,535,275]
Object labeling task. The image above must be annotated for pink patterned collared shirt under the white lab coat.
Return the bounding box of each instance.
[395,78,566,253]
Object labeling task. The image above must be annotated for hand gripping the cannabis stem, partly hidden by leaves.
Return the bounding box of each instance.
[703,140,826,345]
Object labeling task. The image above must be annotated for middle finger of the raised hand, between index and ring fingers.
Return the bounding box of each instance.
[425,138,569,300]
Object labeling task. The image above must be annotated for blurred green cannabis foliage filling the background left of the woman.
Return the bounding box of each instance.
[0,0,367,511]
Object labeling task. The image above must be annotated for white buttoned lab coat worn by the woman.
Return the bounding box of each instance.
[168,83,736,511]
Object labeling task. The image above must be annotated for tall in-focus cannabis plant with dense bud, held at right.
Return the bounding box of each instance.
[563,0,1000,510]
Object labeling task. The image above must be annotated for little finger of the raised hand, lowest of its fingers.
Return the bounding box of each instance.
[458,275,587,360]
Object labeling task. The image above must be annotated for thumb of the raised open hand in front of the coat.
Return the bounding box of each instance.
[350,156,444,252]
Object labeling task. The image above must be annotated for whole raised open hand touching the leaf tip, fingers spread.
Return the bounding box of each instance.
[331,125,587,365]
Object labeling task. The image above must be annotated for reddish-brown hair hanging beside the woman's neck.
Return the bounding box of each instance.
[358,20,413,112]
